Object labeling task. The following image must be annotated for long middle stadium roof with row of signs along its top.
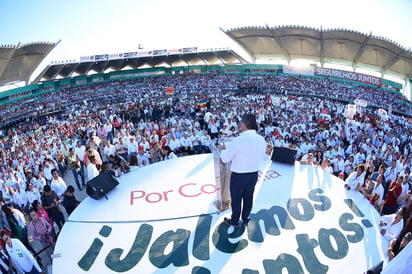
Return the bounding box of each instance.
[34,48,247,83]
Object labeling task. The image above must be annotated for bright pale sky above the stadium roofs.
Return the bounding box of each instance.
[0,0,412,82]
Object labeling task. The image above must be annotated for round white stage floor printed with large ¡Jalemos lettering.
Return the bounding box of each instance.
[53,154,388,274]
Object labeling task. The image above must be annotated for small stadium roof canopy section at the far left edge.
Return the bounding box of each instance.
[0,41,60,86]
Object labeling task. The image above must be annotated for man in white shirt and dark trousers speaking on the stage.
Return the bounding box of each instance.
[220,114,266,228]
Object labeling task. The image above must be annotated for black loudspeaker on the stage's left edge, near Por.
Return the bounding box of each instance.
[86,170,119,200]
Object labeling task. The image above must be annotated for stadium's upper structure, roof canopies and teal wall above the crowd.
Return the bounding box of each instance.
[0,25,412,131]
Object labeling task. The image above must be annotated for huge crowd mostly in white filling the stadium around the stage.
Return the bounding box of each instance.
[0,74,412,269]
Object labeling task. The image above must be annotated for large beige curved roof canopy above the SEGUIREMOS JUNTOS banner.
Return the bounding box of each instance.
[221,25,412,80]
